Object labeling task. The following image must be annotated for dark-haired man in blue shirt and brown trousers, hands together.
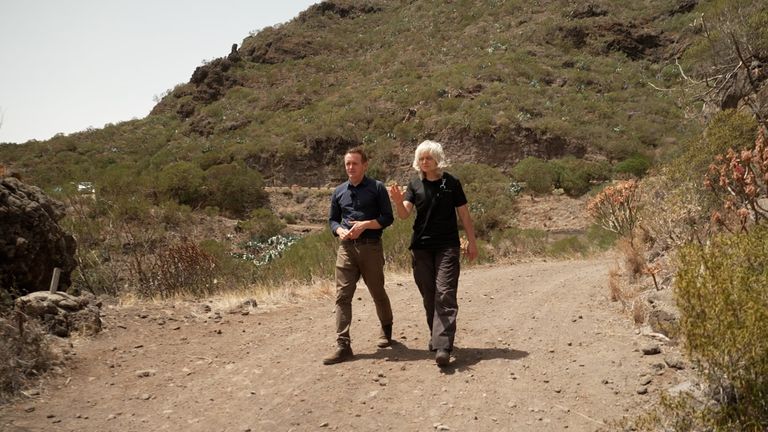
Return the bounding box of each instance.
[323,147,394,365]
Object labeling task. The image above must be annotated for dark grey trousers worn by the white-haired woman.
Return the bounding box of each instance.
[413,247,461,351]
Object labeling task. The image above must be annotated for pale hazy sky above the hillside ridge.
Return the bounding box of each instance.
[0,0,320,143]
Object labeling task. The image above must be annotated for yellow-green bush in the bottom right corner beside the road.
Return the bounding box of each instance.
[675,227,768,431]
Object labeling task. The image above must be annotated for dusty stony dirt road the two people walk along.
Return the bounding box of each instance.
[0,258,685,432]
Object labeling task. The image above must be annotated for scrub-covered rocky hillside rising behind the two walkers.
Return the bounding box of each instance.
[0,0,697,189]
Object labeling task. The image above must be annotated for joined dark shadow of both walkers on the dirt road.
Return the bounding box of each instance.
[354,341,528,374]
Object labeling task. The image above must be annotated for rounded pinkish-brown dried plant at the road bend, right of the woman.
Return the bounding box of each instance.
[587,179,640,237]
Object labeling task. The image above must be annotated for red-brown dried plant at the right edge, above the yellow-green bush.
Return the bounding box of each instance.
[704,128,768,231]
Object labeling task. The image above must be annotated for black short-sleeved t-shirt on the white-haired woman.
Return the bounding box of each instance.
[403,172,467,249]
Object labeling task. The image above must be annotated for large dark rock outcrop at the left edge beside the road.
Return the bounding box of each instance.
[0,177,77,295]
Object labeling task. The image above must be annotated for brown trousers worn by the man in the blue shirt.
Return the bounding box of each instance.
[336,239,392,345]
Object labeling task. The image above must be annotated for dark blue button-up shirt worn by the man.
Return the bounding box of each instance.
[328,177,395,238]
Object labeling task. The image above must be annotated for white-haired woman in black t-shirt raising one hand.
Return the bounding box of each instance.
[389,141,477,367]
